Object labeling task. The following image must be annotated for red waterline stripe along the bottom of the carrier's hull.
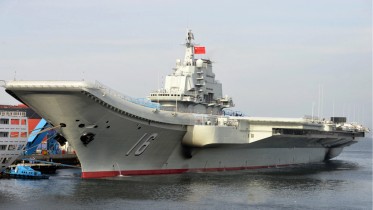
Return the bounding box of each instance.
[82,164,297,178]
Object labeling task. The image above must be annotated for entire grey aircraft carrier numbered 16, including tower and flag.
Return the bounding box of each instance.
[3,30,366,178]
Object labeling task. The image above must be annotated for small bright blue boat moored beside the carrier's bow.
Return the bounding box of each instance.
[8,164,49,179]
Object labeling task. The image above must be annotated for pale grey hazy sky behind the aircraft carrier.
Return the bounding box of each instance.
[0,0,372,128]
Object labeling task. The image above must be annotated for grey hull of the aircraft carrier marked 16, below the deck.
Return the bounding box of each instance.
[3,85,355,178]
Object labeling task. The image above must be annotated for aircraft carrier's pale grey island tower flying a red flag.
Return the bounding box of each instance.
[149,31,233,115]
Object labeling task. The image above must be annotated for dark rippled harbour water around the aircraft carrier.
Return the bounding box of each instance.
[0,138,372,210]
